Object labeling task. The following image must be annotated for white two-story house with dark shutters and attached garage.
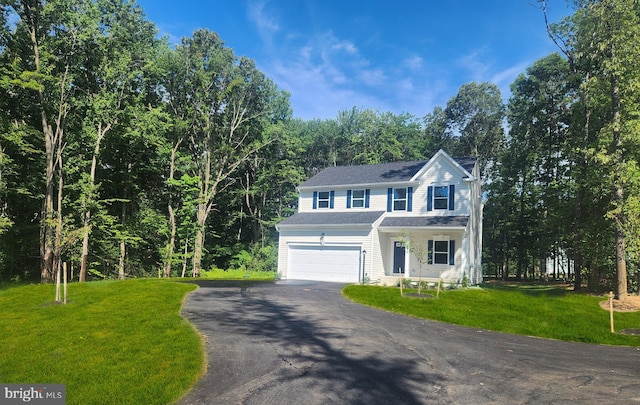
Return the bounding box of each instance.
[276,150,482,285]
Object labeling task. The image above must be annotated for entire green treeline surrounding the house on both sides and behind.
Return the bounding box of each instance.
[0,0,640,295]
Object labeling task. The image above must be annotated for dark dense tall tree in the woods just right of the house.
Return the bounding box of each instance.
[501,53,575,278]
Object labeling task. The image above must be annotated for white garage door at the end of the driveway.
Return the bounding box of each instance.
[287,246,360,283]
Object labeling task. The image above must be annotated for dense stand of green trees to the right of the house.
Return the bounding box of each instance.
[484,0,640,298]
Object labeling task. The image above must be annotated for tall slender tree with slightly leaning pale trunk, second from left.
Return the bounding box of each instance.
[73,0,156,281]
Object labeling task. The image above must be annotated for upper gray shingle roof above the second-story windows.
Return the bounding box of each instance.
[300,157,476,188]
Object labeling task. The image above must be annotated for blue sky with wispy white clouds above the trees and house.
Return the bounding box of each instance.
[138,0,571,119]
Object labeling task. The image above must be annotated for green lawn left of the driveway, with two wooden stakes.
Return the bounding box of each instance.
[0,280,205,405]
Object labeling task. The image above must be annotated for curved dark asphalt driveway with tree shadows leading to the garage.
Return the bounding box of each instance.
[179,281,640,405]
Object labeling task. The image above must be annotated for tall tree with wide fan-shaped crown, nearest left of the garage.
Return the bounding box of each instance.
[165,30,277,276]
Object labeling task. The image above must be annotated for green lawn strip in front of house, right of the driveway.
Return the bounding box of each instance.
[343,285,640,346]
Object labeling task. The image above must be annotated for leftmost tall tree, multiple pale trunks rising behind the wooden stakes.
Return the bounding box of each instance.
[3,0,97,282]
